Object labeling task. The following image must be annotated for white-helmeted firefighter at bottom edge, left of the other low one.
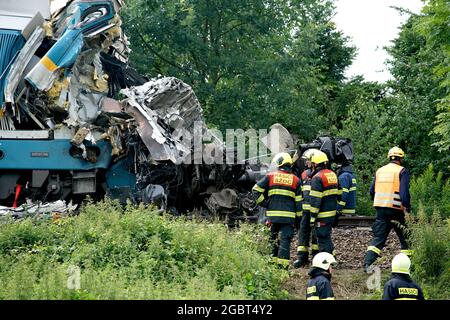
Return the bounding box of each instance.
[306,252,336,300]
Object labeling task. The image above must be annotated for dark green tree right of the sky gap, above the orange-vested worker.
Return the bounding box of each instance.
[388,7,450,174]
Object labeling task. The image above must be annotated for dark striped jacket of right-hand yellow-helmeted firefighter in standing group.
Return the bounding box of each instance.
[309,169,338,222]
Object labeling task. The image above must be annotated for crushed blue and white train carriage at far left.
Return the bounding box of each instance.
[0,0,145,205]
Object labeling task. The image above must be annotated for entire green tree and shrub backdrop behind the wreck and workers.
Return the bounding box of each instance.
[123,0,450,214]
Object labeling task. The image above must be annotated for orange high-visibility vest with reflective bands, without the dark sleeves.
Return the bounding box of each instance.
[373,162,404,210]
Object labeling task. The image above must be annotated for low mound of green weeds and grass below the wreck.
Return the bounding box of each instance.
[0,200,287,299]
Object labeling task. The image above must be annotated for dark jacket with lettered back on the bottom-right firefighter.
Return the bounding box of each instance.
[383,273,425,300]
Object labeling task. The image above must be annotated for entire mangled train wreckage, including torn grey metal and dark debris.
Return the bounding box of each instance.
[0,0,354,224]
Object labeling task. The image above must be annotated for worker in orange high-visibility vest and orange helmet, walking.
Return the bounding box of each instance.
[364,147,412,272]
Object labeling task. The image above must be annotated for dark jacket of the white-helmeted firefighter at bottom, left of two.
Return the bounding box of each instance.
[306,268,335,300]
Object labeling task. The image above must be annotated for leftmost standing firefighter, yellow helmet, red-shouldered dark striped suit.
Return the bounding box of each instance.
[253,153,302,268]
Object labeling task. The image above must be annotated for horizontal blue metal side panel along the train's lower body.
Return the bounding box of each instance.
[0,139,111,170]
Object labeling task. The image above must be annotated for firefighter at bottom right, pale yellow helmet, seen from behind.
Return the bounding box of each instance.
[383,253,425,300]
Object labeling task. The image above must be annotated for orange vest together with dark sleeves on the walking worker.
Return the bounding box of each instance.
[371,162,411,211]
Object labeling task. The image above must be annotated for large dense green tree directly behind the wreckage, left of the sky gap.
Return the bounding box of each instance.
[124,0,354,140]
